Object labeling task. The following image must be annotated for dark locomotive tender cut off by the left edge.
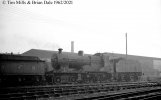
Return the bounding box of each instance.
[0,54,47,86]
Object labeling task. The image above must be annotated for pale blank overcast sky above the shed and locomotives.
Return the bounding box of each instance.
[0,0,161,58]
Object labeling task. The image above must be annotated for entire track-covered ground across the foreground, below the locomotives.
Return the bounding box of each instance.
[0,82,161,100]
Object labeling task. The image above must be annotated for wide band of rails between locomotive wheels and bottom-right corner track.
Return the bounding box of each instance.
[0,82,159,100]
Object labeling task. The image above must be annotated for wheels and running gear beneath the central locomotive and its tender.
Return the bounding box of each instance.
[46,72,141,84]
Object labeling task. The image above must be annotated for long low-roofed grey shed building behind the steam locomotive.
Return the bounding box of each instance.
[22,49,161,78]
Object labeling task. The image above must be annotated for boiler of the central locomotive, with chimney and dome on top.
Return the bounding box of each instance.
[51,49,108,72]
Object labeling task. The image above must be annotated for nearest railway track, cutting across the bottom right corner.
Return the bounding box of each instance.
[75,87,161,100]
